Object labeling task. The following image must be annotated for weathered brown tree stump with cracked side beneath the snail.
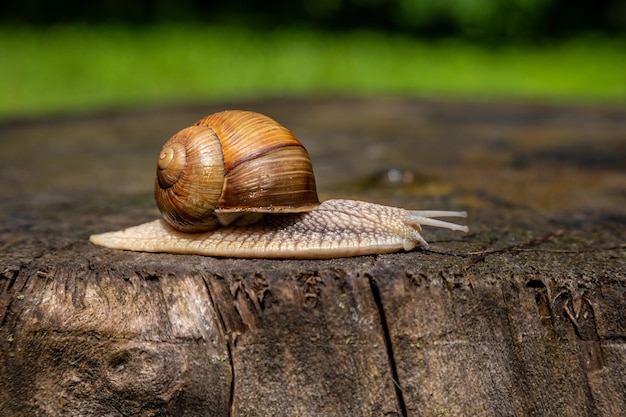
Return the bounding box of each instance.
[0,99,626,417]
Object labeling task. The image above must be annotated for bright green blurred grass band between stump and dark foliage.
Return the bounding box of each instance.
[0,25,626,118]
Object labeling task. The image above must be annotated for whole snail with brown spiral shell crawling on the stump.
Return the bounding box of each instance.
[90,110,468,259]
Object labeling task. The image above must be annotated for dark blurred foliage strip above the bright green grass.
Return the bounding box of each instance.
[0,0,626,43]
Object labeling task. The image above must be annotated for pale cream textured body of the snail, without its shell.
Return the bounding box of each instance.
[90,200,468,259]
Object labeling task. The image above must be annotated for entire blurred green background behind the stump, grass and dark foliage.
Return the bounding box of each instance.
[0,0,626,119]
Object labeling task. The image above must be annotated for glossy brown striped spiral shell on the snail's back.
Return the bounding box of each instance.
[155,111,319,232]
